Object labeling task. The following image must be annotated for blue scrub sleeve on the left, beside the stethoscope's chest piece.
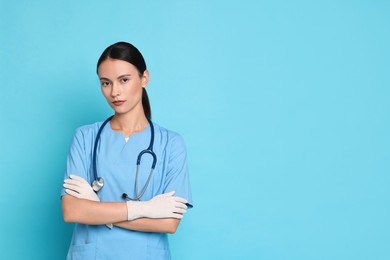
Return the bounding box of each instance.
[61,129,89,197]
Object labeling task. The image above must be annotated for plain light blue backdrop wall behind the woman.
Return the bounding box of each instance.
[0,0,390,260]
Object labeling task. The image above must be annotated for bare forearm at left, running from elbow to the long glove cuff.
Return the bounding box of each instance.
[62,195,127,225]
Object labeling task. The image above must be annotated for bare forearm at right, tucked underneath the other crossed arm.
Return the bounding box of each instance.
[114,218,180,234]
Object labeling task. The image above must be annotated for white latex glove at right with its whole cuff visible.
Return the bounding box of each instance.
[127,191,187,220]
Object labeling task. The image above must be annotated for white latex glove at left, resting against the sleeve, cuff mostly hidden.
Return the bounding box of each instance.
[64,175,112,229]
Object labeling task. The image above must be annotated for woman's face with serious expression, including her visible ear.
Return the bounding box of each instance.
[98,59,149,114]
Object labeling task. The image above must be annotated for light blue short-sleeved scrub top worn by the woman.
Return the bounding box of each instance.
[61,122,192,260]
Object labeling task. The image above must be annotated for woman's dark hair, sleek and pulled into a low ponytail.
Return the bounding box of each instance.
[96,42,152,119]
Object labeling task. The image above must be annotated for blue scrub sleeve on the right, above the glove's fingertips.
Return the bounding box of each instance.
[164,133,193,208]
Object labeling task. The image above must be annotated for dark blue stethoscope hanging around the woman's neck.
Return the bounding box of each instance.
[92,116,157,201]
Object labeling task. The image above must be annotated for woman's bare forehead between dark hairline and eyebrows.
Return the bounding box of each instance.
[98,59,138,78]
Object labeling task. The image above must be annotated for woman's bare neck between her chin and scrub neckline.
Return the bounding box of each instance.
[110,105,149,137]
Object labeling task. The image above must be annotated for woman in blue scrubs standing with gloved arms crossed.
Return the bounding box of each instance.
[61,42,192,260]
